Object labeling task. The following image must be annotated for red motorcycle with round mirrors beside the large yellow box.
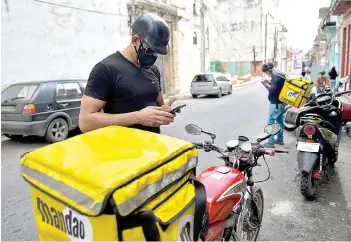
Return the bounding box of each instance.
[185,124,288,241]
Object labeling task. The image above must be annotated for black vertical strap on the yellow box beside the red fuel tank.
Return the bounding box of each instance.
[190,176,207,241]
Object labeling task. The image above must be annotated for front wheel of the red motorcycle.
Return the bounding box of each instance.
[234,189,264,241]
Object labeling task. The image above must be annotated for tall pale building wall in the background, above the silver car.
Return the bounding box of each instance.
[207,0,279,62]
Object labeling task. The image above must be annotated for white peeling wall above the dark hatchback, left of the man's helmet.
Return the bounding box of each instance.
[1,0,130,87]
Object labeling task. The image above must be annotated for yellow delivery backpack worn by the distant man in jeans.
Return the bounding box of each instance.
[279,77,313,108]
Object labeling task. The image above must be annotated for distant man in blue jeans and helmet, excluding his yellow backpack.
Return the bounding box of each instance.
[262,62,286,147]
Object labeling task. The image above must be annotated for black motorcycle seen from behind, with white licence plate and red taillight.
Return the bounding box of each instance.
[297,78,351,200]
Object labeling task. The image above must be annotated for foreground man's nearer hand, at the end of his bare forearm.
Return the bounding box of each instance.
[137,106,173,127]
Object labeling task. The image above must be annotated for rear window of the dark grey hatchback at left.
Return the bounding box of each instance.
[1,84,38,102]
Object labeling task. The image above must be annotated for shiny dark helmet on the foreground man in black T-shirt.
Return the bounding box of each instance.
[132,13,170,55]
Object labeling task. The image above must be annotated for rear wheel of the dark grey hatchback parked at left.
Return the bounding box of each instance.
[45,118,69,143]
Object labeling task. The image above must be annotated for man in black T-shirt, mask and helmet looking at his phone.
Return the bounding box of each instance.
[79,13,175,133]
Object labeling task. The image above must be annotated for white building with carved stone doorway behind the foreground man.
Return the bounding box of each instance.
[1,0,200,94]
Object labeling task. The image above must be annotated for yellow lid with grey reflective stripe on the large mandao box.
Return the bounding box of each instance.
[20,126,197,216]
